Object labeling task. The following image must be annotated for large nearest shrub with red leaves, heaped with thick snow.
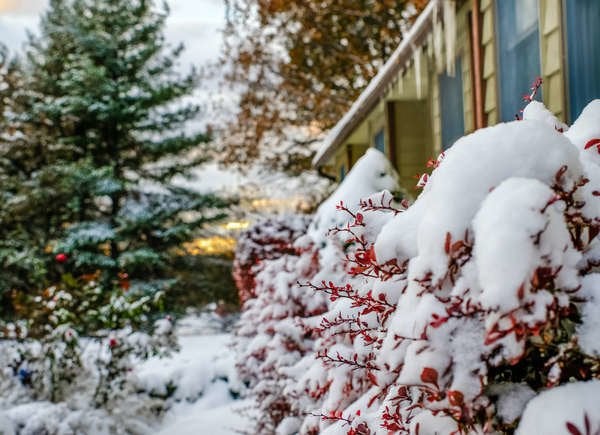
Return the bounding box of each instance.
[234,100,600,435]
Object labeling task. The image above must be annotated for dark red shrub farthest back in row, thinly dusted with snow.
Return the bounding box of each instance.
[233,215,310,303]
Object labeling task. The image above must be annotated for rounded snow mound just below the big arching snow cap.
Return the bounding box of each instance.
[473,178,581,314]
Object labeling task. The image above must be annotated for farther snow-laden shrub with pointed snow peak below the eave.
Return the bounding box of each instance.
[235,150,397,434]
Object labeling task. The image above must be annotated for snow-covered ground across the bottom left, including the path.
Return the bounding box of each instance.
[0,311,250,435]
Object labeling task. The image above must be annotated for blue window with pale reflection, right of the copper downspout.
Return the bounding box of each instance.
[496,0,541,121]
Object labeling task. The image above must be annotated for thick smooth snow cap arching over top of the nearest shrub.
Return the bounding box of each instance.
[375,120,582,280]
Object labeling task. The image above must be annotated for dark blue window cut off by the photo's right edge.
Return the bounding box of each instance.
[565,0,600,121]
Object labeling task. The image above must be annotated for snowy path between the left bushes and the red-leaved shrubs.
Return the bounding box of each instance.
[137,314,250,435]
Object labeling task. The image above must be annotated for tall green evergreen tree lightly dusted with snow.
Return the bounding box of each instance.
[5,0,225,320]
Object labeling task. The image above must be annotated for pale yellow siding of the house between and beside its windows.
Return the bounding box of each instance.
[324,0,580,184]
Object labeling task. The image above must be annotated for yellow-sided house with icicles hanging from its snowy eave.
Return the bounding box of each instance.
[313,0,600,191]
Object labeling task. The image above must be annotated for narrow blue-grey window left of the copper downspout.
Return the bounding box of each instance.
[439,58,465,150]
